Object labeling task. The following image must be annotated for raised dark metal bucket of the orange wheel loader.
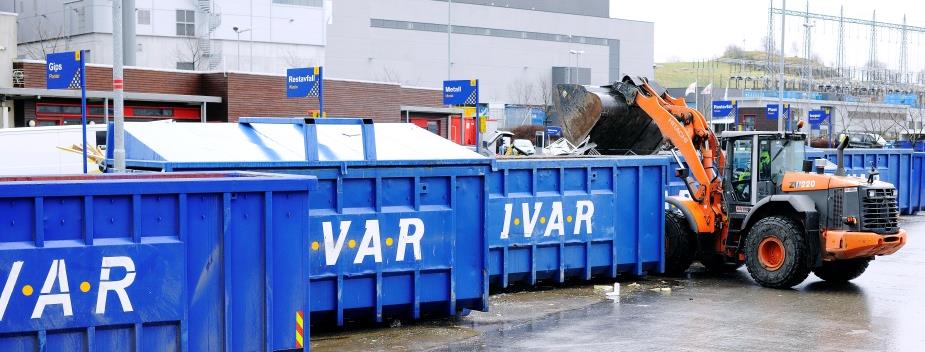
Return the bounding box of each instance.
[554,82,664,155]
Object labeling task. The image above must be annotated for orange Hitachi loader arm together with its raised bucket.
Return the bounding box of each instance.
[557,77,727,234]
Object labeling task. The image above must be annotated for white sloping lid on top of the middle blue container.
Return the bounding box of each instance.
[125,122,486,163]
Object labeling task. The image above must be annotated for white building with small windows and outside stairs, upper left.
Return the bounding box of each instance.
[0,0,330,72]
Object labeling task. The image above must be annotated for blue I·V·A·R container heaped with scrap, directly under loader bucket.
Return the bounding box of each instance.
[485,156,669,287]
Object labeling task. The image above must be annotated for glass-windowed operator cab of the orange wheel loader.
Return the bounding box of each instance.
[720,131,806,209]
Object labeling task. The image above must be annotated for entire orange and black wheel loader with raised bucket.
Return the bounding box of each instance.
[555,77,906,288]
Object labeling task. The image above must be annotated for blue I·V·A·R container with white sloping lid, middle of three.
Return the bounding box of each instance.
[110,118,490,325]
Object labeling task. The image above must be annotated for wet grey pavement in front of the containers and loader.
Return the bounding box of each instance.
[311,216,925,352]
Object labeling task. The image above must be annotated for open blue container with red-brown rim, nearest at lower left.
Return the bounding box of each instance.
[0,173,315,351]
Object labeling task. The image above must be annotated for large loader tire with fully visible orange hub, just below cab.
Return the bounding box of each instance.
[745,216,812,289]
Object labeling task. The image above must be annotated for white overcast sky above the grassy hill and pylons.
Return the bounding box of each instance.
[610,0,925,71]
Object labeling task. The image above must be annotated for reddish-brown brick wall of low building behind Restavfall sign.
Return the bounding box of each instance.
[13,62,443,122]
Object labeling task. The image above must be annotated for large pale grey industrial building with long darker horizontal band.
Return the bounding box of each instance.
[326,0,654,105]
